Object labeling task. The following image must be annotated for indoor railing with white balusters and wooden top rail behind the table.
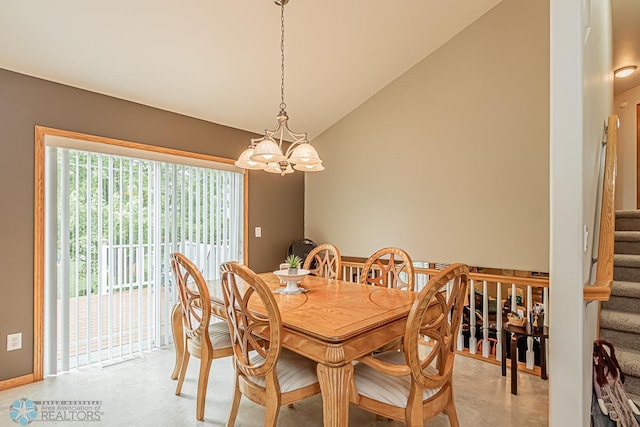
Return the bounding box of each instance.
[342,261,549,370]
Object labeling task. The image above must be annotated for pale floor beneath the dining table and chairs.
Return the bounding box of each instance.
[0,348,549,427]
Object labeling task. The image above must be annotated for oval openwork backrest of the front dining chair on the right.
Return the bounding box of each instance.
[403,263,469,389]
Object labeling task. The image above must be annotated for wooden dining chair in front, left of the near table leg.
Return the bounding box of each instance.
[220,262,320,427]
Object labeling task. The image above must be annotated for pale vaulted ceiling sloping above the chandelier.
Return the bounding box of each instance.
[0,0,640,138]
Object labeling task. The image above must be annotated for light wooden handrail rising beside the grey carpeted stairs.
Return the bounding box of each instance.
[583,114,618,301]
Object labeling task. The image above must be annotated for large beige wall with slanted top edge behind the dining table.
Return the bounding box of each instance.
[305,0,549,271]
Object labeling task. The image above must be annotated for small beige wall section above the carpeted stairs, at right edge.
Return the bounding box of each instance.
[613,86,640,210]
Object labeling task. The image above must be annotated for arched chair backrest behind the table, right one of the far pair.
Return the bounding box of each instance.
[360,248,414,291]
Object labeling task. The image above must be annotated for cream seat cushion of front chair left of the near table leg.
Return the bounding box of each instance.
[249,348,318,393]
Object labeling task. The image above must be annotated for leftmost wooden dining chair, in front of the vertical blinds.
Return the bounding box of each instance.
[170,253,233,421]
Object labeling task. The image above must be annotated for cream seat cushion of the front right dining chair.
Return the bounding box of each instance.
[354,351,440,408]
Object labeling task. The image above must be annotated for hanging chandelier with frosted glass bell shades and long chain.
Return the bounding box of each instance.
[235,0,324,176]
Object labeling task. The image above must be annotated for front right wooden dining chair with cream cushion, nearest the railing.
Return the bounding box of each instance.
[351,264,469,427]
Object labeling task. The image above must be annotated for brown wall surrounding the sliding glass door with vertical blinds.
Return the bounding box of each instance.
[0,69,304,381]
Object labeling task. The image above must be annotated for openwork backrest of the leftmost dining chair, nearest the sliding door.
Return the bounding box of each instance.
[170,252,211,347]
